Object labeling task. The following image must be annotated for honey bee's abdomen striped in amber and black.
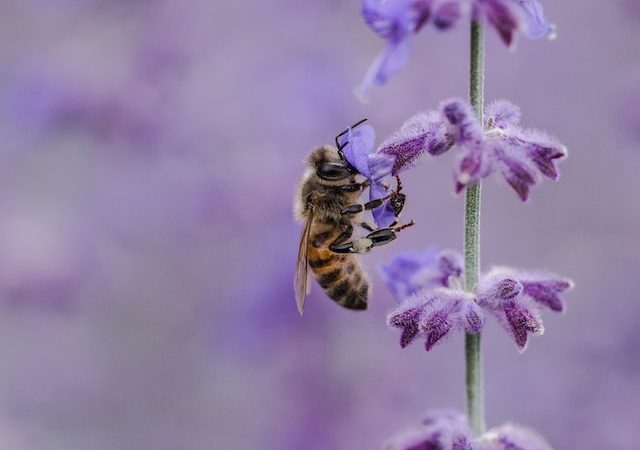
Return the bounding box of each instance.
[307,229,369,310]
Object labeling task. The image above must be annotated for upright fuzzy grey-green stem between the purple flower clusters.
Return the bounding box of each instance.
[464,20,485,436]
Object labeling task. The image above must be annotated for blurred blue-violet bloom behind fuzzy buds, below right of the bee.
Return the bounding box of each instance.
[378,247,464,302]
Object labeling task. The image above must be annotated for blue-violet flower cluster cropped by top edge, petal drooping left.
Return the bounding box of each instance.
[356,0,555,101]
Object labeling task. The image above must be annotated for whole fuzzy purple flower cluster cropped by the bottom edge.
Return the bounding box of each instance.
[383,410,552,450]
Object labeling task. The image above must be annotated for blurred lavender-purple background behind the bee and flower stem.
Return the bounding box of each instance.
[0,0,640,450]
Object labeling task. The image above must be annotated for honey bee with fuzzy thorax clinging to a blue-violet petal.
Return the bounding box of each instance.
[294,119,413,314]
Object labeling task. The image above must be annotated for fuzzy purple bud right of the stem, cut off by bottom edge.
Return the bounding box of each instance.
[474,423,552,450]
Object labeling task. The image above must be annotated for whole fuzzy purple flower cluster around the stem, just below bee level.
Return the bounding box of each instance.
[380,250,573,351]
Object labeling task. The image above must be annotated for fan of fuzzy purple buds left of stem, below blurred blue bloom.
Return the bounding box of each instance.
[387,288,484,351]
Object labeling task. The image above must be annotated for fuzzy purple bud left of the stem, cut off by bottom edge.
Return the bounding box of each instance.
[383,411,472,450]
